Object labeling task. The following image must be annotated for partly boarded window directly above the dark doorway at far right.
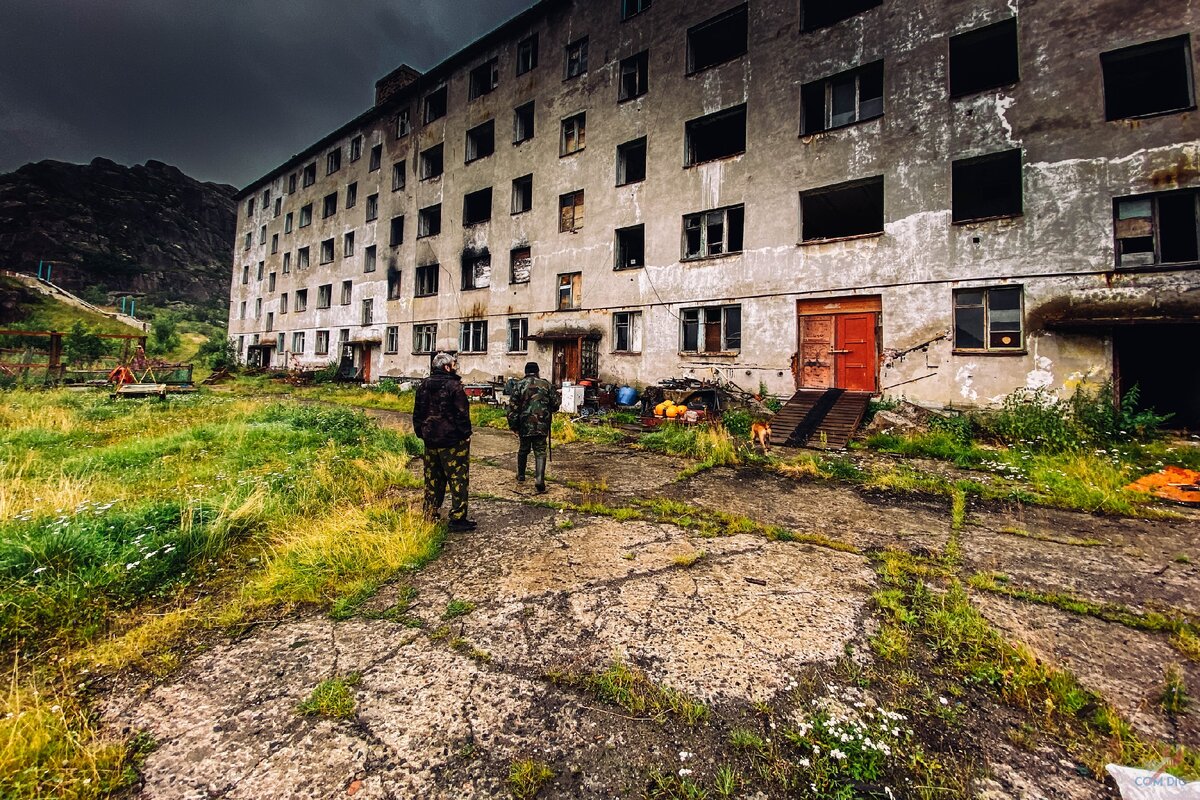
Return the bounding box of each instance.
[1114,190,1200,266]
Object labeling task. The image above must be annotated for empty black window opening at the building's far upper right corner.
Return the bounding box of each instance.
[1100,35,1195,120]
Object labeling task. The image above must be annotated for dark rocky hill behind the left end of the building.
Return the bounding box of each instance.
[0,158,236,319]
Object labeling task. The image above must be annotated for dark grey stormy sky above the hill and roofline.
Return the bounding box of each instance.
[0,0,533,187]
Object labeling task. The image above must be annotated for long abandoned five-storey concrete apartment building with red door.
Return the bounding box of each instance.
[229,0,1200,426]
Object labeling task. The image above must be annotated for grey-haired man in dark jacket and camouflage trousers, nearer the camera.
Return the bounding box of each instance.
[413,353,475,530]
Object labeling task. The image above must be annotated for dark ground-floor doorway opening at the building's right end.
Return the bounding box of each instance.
[1114,323,1200,431]
